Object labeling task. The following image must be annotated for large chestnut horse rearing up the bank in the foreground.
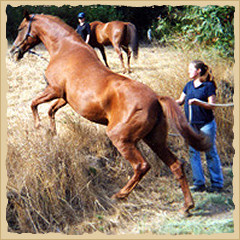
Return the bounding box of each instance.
[11,13,209,217]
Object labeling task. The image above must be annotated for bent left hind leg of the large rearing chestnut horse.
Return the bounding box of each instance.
[107,129,150,199]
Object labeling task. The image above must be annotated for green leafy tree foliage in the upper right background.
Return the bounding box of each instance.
[153,5,235,57]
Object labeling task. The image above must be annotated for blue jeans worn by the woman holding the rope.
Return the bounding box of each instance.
[189,120,223,188]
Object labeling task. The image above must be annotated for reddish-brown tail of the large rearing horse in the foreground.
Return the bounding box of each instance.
[158,96,211,151]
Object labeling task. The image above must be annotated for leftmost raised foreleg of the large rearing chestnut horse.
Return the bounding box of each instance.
[31,85,60,128]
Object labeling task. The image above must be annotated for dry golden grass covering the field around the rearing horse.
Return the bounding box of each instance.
[6,43,234,234]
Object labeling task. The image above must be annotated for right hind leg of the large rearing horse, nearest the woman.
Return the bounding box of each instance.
[144,122,194,215]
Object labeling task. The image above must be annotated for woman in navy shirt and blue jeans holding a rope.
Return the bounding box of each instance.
[176,60,223,192]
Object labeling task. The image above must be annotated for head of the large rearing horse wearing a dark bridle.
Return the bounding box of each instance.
[10,11,40,60]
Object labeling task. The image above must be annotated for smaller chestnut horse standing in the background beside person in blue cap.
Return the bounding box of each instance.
[89,21,138,73]
